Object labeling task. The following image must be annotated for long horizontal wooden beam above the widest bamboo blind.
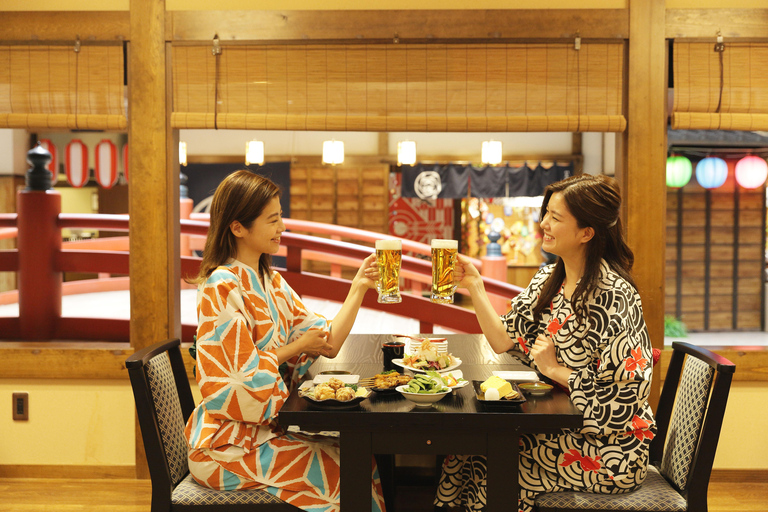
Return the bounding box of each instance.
[172,9,629,43]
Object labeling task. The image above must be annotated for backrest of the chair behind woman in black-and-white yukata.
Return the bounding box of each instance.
[650,342,736,510]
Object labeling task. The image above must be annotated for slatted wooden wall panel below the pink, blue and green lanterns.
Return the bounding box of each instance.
[664,182,765,331]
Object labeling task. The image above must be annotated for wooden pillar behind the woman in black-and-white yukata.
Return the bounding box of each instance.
[617,0,667,406]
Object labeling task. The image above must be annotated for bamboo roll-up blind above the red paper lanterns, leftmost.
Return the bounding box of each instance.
[0,45,127,130]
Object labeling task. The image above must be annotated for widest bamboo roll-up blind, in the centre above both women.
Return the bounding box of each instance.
[171,42,626,132]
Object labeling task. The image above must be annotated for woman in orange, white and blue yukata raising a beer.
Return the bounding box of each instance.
[185,171,384,512]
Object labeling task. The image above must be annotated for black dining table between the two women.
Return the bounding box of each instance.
[278,334,583,512]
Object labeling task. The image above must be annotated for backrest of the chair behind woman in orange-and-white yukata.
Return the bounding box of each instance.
[125,339,194,496]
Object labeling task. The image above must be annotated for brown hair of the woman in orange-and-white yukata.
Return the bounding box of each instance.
[191,170,280,284]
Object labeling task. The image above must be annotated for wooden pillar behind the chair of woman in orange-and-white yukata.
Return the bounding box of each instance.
[128,0,181,478]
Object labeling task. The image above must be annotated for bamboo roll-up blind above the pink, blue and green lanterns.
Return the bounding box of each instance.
[672,42,768,131]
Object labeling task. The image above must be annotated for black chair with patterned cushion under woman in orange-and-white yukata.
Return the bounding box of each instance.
[125,339,301,512]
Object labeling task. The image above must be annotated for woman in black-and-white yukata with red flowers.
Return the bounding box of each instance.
[435,175,656,512]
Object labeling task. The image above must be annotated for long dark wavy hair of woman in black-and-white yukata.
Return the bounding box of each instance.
[533,174,637,323]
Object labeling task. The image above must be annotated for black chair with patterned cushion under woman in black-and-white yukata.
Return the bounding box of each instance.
[536,342,736,512]
